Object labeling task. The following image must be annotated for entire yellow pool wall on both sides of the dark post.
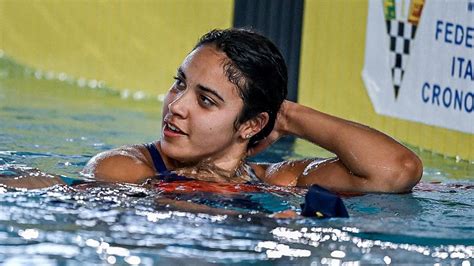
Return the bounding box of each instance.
[0,0,474,161]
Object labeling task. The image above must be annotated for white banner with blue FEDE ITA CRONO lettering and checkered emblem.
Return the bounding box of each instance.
[362,0,474,134]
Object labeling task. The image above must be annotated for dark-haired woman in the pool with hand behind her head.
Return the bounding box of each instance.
[84,29,422,193]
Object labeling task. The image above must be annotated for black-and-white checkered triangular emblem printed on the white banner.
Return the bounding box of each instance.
[386,20,416,98]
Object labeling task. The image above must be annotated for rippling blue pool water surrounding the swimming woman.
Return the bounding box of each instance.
[0,56,474,265]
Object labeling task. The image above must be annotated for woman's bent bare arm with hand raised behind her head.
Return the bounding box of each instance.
[252,101,423,193]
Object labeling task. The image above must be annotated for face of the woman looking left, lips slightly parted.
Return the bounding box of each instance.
[161,45,243,163]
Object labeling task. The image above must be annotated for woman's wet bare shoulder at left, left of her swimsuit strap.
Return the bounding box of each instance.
[83,144,155,183]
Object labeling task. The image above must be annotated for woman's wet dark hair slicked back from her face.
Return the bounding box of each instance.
[193,28,288,147]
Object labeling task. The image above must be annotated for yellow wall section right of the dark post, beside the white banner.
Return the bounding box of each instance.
[299,0,474,161]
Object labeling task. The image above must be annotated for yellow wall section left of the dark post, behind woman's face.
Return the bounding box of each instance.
[0,0,233,95]
